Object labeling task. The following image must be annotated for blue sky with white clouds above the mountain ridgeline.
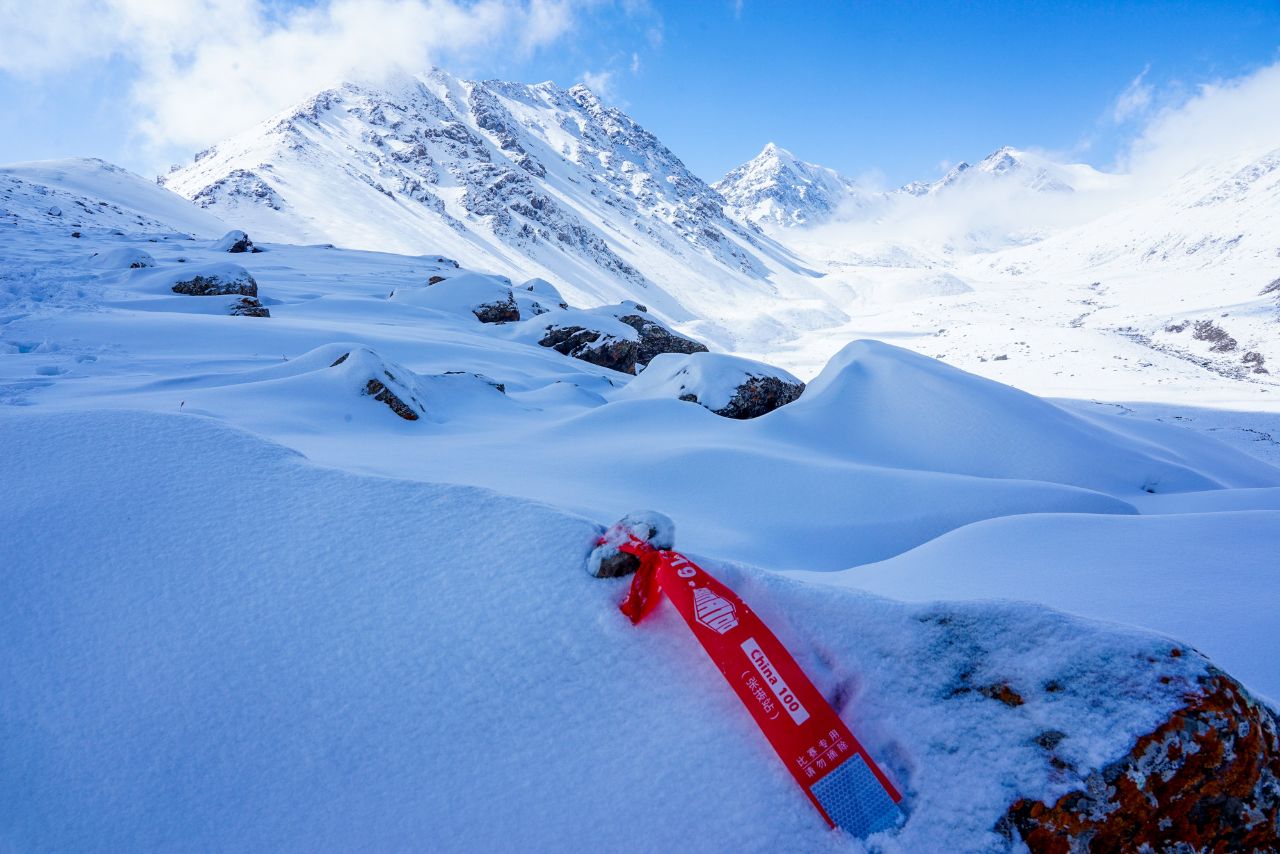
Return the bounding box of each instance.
[0,0,1280,183]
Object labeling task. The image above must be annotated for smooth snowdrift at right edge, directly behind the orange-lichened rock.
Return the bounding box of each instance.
[822,512,1280,703]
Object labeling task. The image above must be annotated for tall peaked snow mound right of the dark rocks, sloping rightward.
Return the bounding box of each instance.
[768,341,1280,495]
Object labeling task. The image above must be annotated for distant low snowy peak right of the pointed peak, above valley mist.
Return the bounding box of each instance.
[897,146,1115,196]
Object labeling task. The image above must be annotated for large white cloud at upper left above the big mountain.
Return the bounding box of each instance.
[0,0,596,147]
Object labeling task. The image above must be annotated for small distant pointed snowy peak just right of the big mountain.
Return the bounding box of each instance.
[713,142,876,227]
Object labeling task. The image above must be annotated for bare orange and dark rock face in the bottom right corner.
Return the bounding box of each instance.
[997,671,1280,854]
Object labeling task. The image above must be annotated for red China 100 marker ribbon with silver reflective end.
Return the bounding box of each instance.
[616,536,902,839]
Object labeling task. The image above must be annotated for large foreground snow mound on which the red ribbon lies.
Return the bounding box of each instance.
[0,407,1228,851]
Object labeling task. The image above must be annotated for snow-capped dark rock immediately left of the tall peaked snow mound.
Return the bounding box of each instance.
[618,352,804,419]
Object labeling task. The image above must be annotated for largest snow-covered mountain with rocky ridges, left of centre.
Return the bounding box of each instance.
[161,70,838,343]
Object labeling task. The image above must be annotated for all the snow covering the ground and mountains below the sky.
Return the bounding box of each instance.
[0,73,1280,853]
